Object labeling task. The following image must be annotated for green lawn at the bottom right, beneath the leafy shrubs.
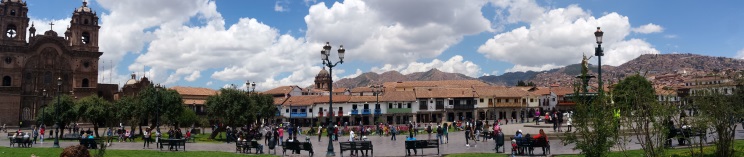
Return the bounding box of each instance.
[446,140,744,157]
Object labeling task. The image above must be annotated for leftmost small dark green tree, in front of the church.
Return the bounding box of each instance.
[37,95,78,136]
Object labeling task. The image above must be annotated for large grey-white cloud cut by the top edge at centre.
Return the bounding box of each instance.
[305,0,490,65]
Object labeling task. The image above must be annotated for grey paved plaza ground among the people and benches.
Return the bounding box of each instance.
[0,123,744,156]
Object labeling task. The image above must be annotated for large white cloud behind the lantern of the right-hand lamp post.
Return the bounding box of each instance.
[478,1,658,72]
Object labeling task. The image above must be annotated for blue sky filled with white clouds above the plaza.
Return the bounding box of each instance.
[21,0,744,91]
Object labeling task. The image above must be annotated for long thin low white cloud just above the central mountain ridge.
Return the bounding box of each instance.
[372,55,481,77]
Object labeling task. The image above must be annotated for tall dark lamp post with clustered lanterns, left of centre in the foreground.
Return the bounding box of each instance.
[320,42,346,156]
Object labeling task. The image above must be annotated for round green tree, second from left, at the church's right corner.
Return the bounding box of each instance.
[75,95,113,137]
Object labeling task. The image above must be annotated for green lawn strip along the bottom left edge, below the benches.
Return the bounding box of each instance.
[0,147,272,157]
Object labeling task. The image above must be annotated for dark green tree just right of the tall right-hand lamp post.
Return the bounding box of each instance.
[612,74,676,156]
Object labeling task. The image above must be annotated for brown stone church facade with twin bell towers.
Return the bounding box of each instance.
[0,0,104,126]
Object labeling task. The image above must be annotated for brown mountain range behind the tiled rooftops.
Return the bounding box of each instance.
[334,54,744,88]
